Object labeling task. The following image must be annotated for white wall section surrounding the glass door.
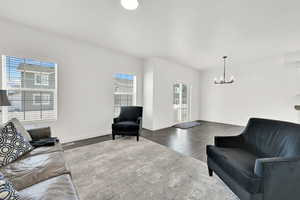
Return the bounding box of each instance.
[144,58,199,130]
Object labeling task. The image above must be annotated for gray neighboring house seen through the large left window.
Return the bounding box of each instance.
[14,63,56,111]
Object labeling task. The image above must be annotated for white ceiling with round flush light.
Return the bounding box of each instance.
[0,0,300,69]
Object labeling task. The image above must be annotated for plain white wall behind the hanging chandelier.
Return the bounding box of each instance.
[199,56,300,125]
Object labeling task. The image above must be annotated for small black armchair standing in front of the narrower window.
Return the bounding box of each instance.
[112,106,143,141]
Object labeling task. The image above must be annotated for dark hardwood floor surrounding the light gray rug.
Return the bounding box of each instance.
[63,121,243,161]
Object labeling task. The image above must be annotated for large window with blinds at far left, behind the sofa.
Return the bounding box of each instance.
[0,55,57,123]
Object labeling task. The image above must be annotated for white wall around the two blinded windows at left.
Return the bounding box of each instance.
[0,20,143,142]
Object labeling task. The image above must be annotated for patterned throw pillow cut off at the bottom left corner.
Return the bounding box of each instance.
[0,174,21,200]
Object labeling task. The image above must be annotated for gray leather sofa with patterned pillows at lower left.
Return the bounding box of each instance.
[0,128,79,200]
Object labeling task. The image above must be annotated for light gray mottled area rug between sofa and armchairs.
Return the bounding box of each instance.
[65,137,238,200]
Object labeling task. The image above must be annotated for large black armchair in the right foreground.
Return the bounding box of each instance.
[207,118,300,200]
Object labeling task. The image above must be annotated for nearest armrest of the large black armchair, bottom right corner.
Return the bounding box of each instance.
[254,157,300,200]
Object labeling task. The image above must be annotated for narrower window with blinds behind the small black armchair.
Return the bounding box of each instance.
[113,74,136,117]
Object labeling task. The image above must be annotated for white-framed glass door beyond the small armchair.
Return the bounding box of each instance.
[173,83,190,122]
